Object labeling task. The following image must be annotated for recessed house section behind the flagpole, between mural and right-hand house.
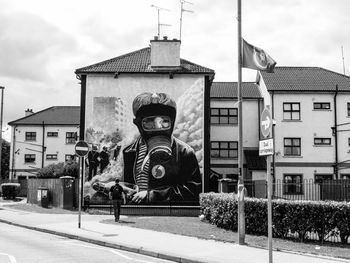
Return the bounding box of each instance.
[210,82,266,191]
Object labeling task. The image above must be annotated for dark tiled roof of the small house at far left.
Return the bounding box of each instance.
[9,106,80,126]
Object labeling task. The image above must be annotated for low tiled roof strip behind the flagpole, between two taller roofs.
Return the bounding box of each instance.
[210,82,262,99]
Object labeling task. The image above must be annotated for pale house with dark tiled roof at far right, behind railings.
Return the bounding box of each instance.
[257,67,350,200]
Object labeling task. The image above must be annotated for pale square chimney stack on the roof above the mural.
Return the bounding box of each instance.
[151,36,181,70]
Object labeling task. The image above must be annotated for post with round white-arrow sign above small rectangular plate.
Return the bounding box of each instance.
[259,107,274,263]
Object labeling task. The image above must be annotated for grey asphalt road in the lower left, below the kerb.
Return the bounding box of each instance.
[0,223,173,263]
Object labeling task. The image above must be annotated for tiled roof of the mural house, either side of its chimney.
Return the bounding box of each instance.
[75,47,214,74]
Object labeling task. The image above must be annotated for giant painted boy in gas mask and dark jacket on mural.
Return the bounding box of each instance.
[123,93,201,203]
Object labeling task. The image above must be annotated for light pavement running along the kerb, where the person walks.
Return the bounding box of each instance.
[0,202,350,263]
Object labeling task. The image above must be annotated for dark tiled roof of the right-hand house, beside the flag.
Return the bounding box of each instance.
[261,67,350,92]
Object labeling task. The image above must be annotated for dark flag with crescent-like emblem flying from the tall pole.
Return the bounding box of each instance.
[242,38,276,73]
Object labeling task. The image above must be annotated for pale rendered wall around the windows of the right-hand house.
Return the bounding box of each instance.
[273,93,350,182]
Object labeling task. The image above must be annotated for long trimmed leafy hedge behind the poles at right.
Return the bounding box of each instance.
[200,193,350,244]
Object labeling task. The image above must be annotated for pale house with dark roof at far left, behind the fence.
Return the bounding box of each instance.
[9,106,80,180]
